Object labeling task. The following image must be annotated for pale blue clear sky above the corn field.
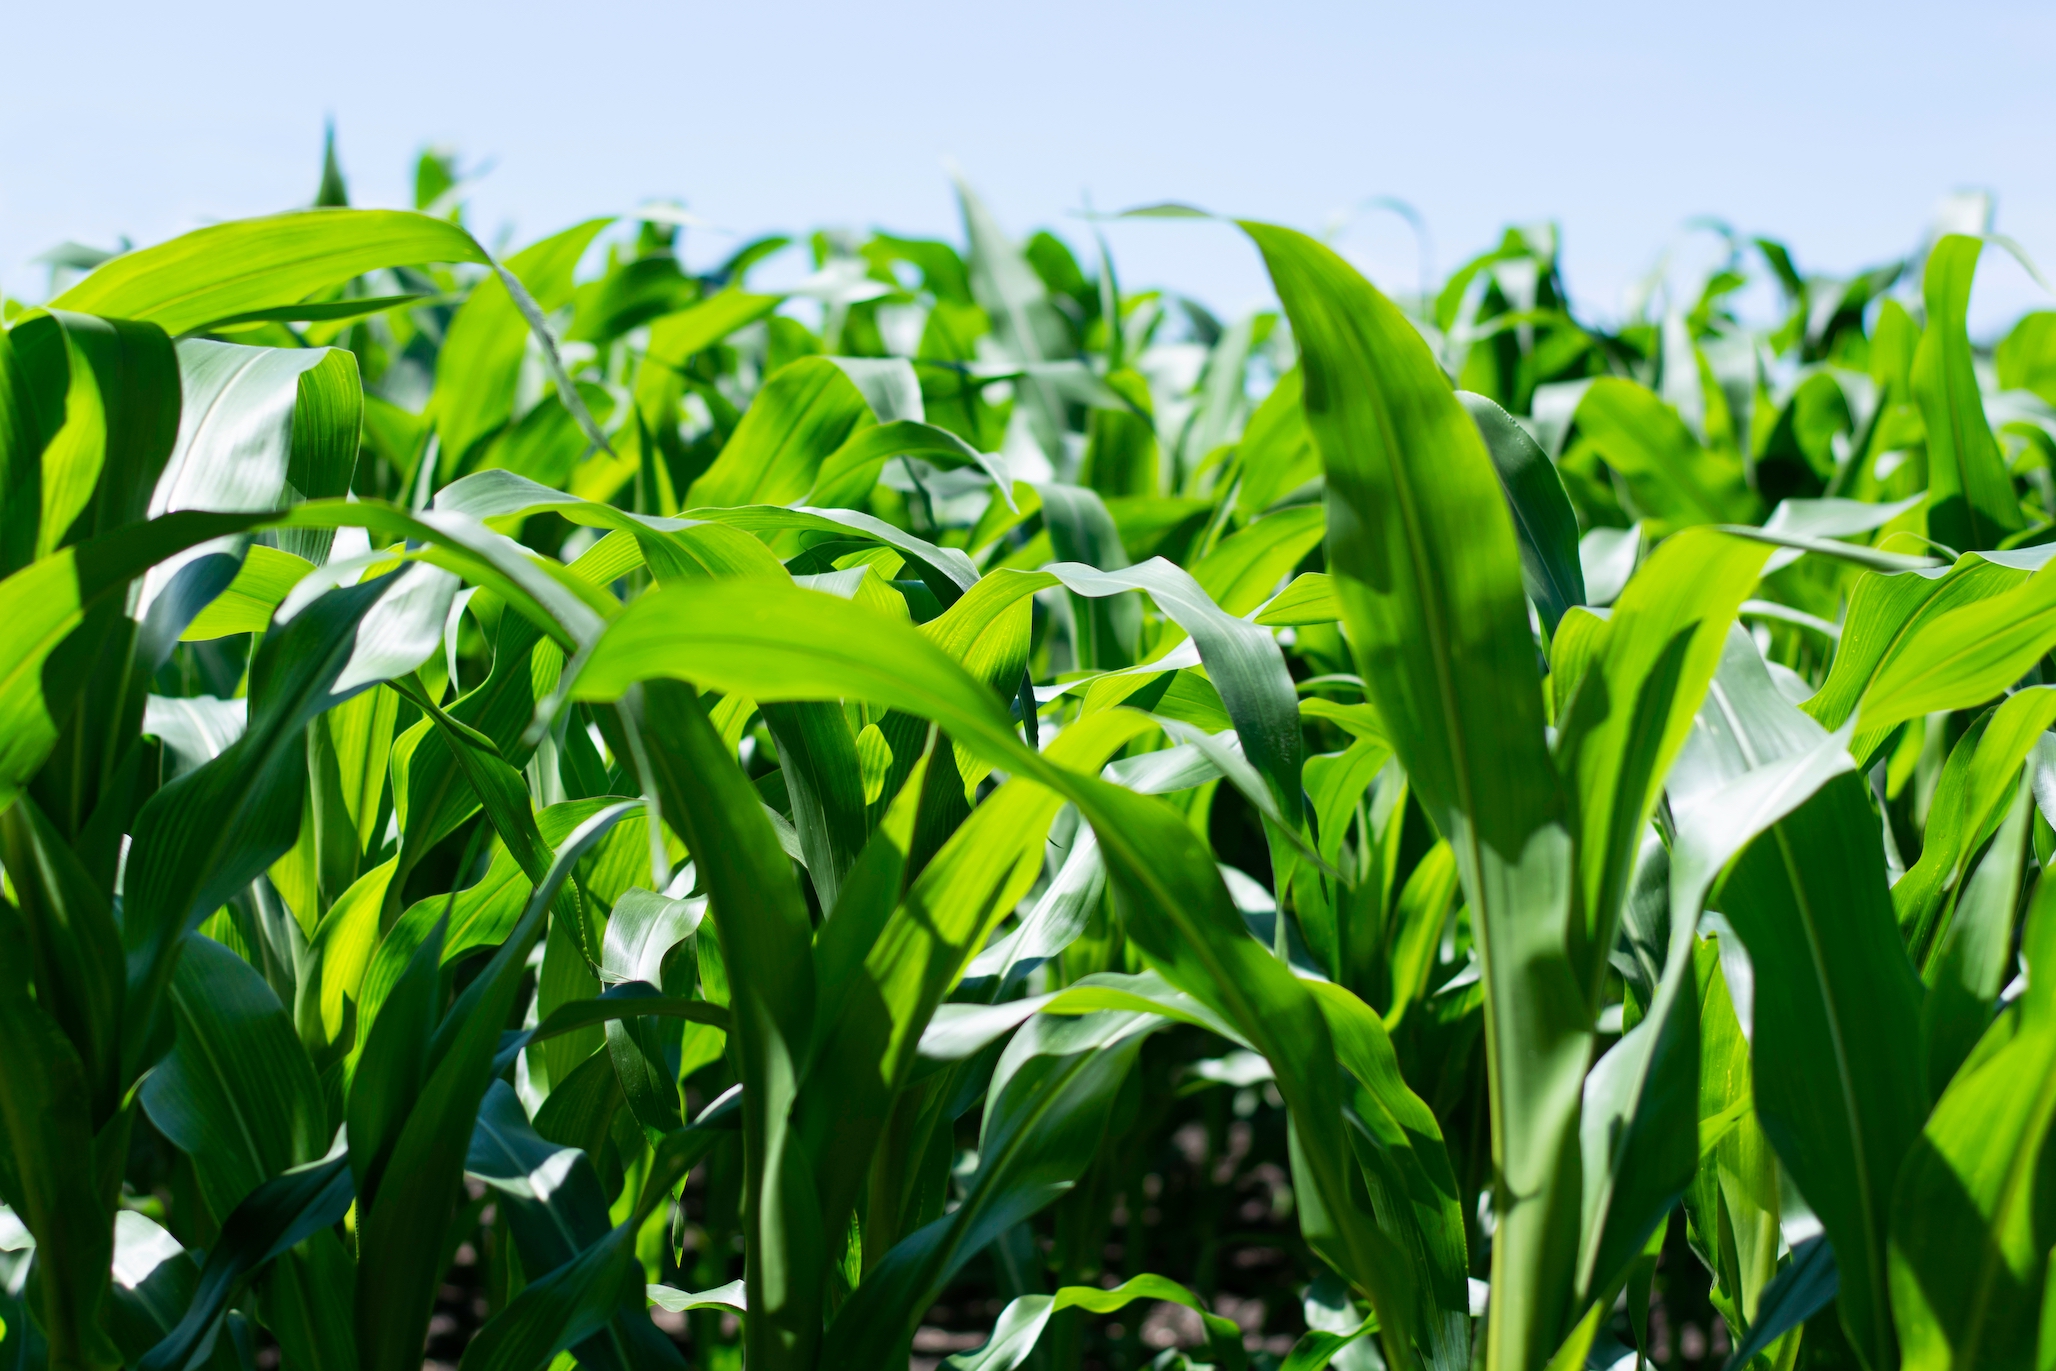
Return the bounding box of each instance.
[0,0,2056,331]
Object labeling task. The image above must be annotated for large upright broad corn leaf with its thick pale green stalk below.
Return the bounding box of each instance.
[1233,224,1591,1371]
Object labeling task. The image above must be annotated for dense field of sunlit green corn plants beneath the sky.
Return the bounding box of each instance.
[0,141,2056,1371]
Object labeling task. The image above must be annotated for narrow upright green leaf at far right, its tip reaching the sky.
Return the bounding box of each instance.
[1912,234,2023,553]
